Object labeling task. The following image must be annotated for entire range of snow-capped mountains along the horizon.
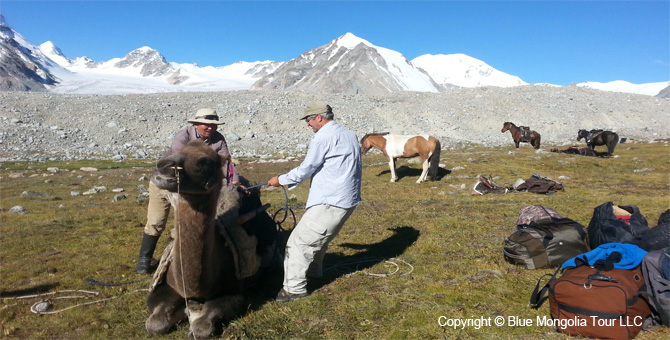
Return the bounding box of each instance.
[0,14,670,96]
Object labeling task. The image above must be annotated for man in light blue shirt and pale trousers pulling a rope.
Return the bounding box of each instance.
[268,102,362,302]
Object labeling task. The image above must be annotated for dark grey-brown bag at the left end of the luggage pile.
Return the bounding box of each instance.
[503,217,591,269]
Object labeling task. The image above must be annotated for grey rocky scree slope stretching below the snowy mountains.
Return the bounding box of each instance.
[0,85,670,161]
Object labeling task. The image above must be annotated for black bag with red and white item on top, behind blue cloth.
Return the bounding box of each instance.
[588,202,649,249]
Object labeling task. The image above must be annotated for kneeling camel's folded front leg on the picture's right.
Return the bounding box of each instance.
[188,295,243,339]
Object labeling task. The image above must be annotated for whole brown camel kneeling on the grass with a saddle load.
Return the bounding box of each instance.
[145,141,276,339]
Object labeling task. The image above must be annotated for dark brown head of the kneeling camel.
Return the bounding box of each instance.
[151,140,230,194]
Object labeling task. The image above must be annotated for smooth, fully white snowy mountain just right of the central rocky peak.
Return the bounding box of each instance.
[412,54,528,87]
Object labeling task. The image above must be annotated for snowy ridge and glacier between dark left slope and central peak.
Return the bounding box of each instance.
[40,42,281,94]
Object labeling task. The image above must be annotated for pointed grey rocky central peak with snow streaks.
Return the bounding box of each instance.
[251,33,439,94]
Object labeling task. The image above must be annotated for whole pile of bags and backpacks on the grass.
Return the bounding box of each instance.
[503,202,670,339]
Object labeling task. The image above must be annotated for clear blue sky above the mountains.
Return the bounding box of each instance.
[0,0,670,85]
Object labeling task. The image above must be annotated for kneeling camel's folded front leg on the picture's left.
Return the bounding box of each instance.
[145,284,186,334]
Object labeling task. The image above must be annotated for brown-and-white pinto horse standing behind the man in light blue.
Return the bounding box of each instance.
[361,132,441,183]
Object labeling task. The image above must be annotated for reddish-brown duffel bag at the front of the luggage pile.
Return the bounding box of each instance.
[549,265,651,339]
